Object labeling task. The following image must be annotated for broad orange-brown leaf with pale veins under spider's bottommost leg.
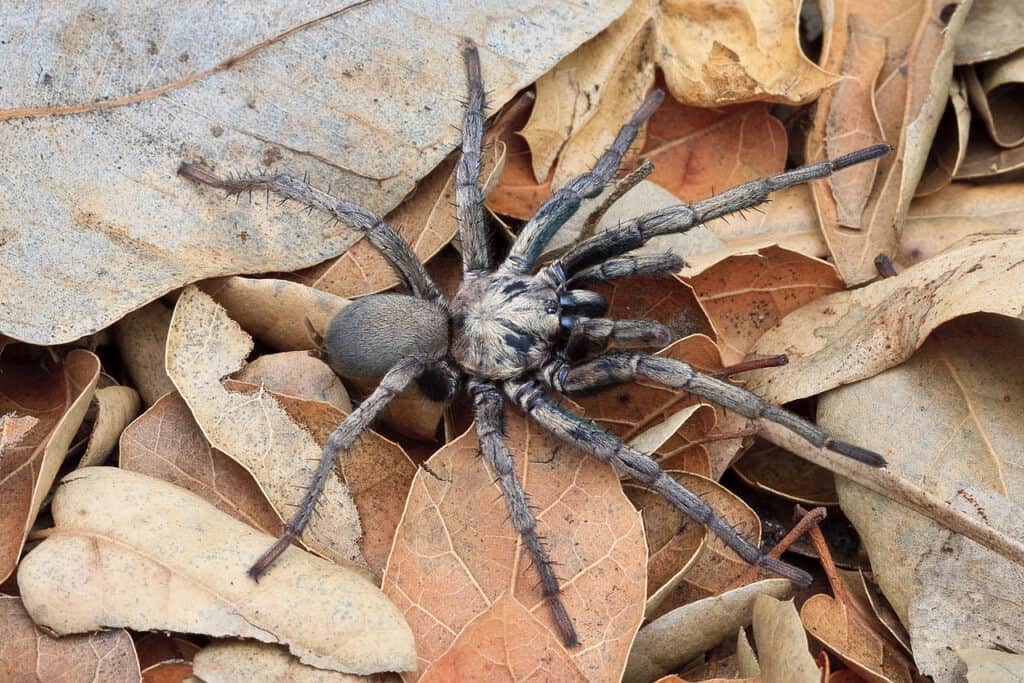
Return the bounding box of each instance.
[383,411,647,681]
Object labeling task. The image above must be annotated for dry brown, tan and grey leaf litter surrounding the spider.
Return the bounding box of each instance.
[0,0,1024,683]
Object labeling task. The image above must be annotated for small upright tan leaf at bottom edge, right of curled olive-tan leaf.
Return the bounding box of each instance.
[754,593,821,683]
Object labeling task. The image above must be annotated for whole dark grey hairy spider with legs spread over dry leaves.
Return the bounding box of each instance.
[179,45,891,647]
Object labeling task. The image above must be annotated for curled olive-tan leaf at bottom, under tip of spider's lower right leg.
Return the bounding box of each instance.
[623,579,793,683]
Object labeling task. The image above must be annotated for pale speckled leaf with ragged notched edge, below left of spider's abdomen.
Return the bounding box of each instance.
[167,287,361,562]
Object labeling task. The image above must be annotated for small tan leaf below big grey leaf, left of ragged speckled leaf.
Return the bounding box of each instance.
[114,300,174,408]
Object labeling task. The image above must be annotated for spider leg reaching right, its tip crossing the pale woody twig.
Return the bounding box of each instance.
[541,351,886,467]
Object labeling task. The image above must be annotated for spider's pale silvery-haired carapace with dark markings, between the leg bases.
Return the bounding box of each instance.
[452,274,559,380]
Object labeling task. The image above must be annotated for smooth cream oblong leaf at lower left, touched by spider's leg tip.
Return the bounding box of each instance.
[17,467,416,674]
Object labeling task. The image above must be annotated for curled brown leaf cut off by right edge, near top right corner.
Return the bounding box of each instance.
[966,52,1024,147]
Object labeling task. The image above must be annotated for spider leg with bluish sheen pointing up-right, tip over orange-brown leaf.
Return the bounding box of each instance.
[502,90,665,275]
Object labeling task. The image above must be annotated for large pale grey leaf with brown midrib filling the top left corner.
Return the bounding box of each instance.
[0,0,627,344]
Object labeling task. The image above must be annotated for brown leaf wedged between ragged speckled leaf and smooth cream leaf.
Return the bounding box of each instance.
[118,391,285,536]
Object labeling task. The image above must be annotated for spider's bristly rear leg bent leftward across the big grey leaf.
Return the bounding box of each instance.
[178,163,441,299]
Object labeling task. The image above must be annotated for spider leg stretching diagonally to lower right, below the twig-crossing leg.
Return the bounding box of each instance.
[503,380,811,586]
